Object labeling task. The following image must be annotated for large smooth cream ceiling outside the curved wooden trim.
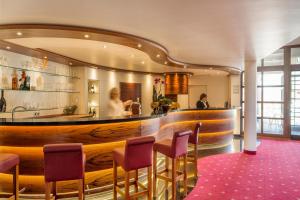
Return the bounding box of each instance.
[0,0,300,71]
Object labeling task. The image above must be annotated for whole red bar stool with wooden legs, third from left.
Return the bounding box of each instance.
[113,136,155,200]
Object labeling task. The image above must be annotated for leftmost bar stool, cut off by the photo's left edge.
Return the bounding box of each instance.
[0,153,20,200]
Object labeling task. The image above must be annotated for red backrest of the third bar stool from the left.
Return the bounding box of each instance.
[124,136,155,170]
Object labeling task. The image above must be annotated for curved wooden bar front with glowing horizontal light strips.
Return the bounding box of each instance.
[0,109,235,193]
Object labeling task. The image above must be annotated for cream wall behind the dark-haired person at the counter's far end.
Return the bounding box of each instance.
[189,75,229,107]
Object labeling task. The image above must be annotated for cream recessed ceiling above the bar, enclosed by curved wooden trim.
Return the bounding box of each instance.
[6,37,228,75]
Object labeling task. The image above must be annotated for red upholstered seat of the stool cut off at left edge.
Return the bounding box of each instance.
[0,153,20,173]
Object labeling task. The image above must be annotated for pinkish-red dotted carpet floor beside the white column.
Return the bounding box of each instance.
[186,139,300,200]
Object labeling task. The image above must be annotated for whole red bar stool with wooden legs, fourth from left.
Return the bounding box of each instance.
[153,131,192,200]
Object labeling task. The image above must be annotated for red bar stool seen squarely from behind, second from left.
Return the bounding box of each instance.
[44,143,85,200]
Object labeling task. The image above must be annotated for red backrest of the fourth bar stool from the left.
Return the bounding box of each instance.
[171,131,192,157]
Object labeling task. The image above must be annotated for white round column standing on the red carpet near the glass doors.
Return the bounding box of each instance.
[244,60,257,154]
